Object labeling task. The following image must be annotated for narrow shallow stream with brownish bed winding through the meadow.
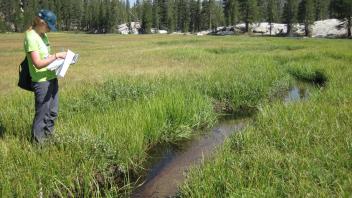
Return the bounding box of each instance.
[132,84,309,198]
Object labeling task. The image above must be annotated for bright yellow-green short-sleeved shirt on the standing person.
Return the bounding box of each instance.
[24,30,56,82]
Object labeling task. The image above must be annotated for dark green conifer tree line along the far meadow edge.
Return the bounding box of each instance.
[0,0,352,36]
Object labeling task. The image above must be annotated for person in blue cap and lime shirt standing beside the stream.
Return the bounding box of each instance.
[24,10,66,143]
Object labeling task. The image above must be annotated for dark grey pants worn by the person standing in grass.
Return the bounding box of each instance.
[32,79,59,143]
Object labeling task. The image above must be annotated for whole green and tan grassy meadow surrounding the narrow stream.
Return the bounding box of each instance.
[0,33,352,197]
